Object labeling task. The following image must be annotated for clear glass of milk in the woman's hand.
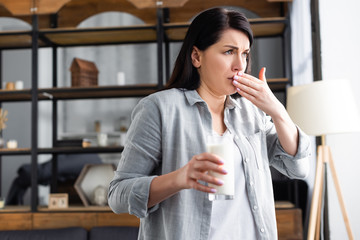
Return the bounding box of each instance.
[206,133,235,201]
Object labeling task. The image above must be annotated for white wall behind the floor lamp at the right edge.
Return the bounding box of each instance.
[319,0,360,239]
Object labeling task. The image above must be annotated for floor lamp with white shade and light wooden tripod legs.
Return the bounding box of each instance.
[287,79,360,240]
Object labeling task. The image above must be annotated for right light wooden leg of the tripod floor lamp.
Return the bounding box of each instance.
[327,147,354,240]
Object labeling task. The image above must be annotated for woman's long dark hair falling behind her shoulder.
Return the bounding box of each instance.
[166,8,254,90]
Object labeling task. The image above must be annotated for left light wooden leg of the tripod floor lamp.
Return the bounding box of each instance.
[307,146,324,240]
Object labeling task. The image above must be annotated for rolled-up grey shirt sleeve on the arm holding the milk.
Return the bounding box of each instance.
[108,98,161,218]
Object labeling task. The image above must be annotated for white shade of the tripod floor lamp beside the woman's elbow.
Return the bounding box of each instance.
[286,79,360,136]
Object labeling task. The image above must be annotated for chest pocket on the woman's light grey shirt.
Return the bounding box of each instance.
[246,131,269,170]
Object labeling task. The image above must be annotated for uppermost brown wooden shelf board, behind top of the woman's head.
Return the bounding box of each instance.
[0,17,286,48]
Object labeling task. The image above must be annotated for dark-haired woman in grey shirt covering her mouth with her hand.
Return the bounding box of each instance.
[109,8,309,240]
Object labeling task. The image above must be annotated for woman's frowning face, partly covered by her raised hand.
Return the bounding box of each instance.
[192,29,250,95]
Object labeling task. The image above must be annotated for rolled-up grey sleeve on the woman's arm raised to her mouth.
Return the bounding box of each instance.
[265,117,310,179]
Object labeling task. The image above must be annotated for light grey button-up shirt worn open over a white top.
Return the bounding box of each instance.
[108,89,310,240]
